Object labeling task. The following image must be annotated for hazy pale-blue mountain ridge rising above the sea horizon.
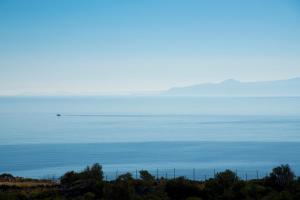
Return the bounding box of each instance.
[162,78,300,96]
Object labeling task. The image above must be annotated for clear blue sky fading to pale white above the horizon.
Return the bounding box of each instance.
[0,0,300,95]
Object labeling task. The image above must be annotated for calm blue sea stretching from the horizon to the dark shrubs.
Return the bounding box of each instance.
[0,96,300,179]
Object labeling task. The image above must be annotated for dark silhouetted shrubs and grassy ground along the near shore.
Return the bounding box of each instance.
[0,164,300,200]
